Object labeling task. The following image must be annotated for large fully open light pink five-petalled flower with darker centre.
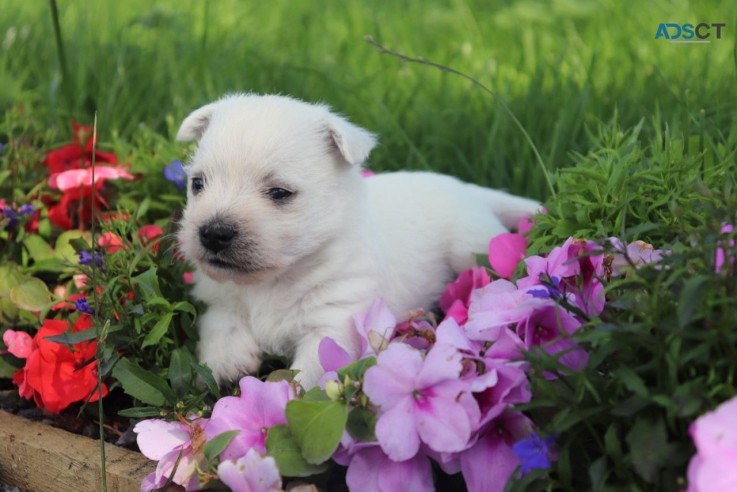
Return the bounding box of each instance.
[364,343,480,461]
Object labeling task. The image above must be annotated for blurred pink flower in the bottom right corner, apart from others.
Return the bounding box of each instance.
[688,397,737,492]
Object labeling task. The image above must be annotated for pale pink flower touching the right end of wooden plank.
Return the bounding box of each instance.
[133,419,208,492]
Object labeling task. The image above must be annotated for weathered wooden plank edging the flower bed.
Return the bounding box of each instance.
[0,410,156,492]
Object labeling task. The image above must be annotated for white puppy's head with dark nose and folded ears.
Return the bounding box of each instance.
[177,95,376,283]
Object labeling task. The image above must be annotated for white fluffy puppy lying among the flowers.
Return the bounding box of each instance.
[177,94,539,387]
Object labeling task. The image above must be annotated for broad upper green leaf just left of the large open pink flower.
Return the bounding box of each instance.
[286,400,348,465]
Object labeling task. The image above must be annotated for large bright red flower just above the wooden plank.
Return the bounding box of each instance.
[13,316,108,413]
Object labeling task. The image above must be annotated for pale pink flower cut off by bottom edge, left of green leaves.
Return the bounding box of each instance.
[218,449,282,492]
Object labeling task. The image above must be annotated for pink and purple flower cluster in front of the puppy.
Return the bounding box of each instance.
[136,228,661,492]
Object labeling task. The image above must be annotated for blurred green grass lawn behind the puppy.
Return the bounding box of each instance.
[0,0,737,199]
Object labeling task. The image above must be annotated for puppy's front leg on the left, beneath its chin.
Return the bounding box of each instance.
[197,306,261,383]
